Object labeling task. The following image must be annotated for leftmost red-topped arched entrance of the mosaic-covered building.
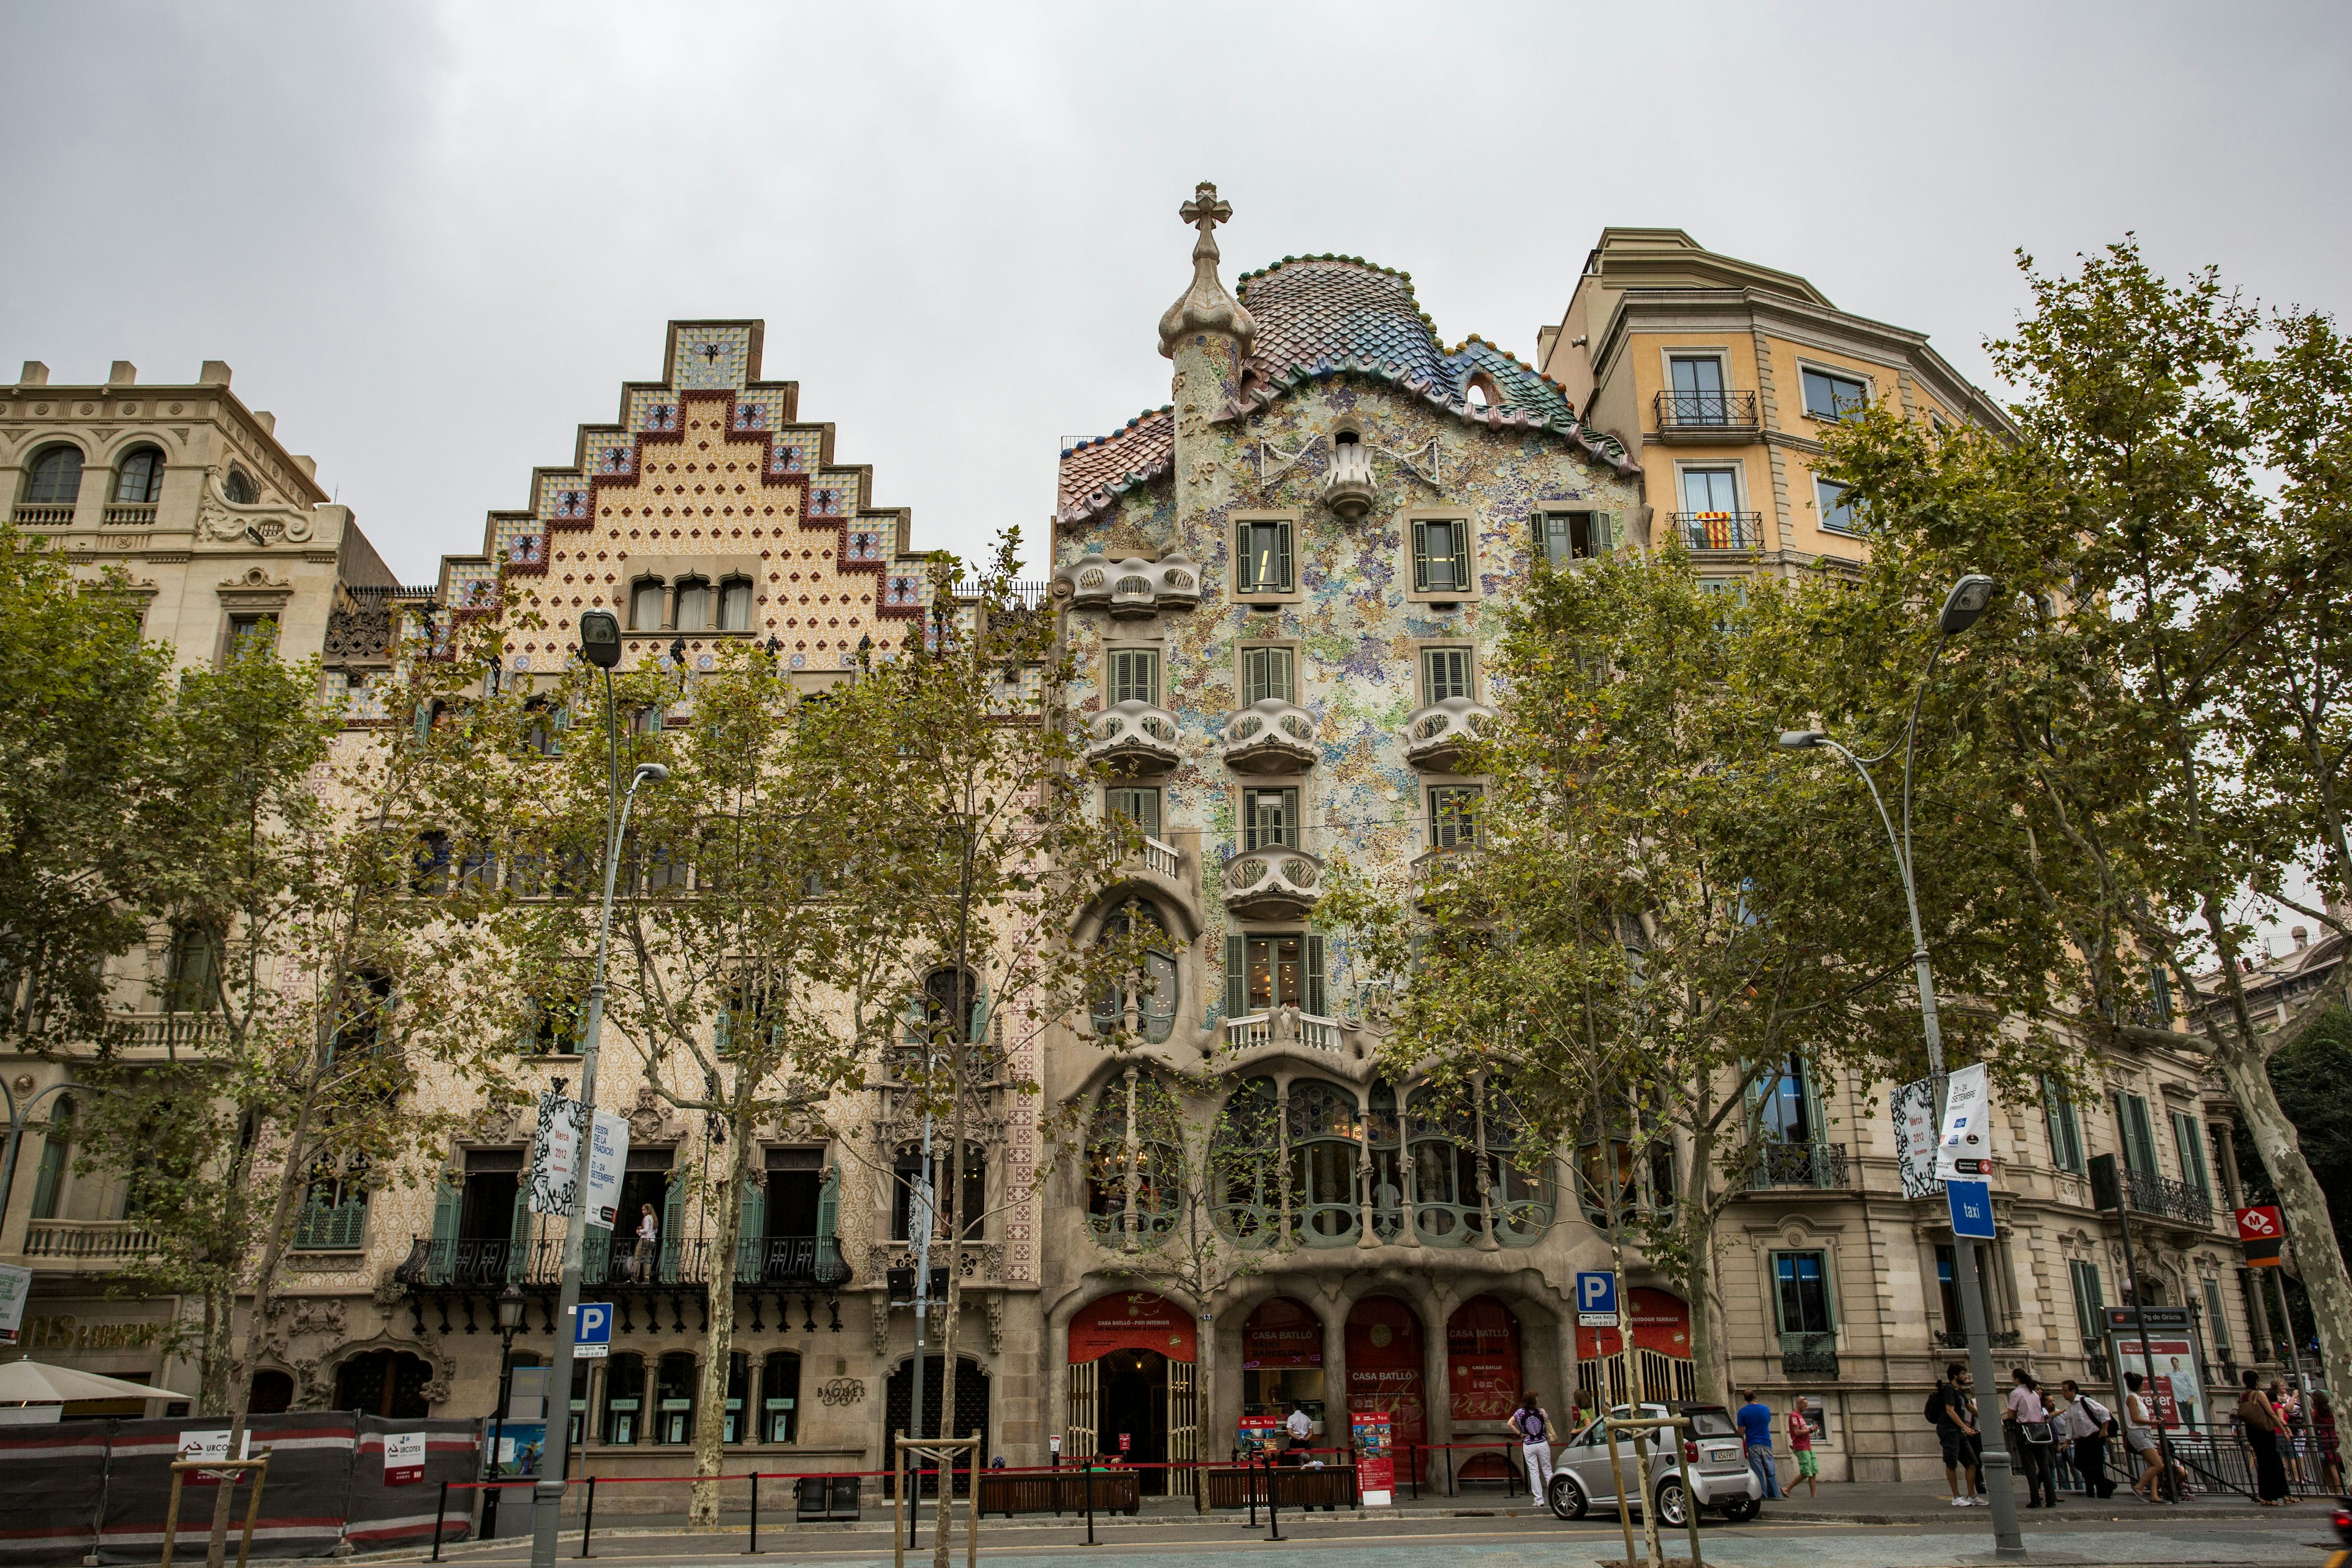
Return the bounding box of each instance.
[1063,1291,1199,1495]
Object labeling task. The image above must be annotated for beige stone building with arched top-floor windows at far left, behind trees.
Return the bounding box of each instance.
[0,360,395,1413]
